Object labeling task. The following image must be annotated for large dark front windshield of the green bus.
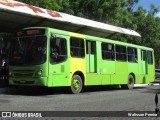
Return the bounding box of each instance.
[9,36,47,65]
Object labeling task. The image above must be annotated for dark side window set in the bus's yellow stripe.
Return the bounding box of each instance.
[70,37,84,58]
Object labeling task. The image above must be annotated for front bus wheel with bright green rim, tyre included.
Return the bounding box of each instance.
[71,75,82,94]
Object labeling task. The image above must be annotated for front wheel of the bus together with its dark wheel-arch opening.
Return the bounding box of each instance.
[70,71,84,94]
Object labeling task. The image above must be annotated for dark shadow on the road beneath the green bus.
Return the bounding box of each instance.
[0,86,145,96]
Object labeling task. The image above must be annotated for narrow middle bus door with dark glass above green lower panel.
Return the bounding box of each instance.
[86,41,97,73]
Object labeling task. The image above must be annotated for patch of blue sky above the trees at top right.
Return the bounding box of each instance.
[134,0,160,17]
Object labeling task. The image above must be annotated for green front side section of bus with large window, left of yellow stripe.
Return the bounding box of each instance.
[48,34,69,86]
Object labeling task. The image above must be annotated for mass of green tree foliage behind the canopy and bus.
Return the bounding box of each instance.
[17,0,160,66]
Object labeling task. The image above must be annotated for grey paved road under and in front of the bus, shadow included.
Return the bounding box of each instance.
[0,85,160,119]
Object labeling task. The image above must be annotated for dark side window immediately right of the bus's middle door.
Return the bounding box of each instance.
[101,43,115,60]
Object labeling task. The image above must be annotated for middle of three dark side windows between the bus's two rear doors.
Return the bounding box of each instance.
[116,45,127,61]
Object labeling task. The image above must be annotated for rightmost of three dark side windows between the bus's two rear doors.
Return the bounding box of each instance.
[127,47,138,62]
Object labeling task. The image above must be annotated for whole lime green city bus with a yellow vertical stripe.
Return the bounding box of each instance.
[9,27,155,94]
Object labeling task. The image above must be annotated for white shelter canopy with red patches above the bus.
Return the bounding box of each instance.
[0,0,140,37]
